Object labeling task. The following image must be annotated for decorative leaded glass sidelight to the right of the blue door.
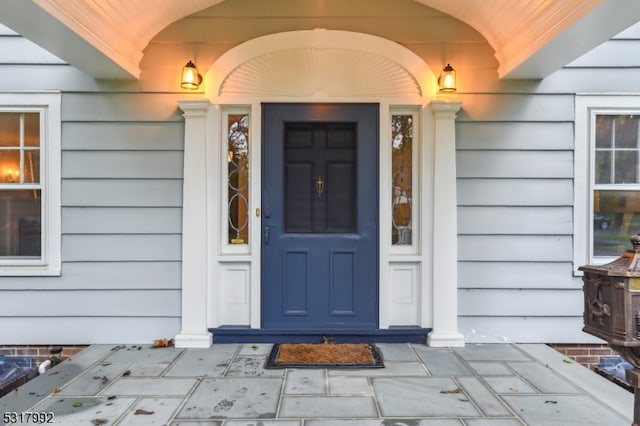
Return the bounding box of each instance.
[391,114,414,245]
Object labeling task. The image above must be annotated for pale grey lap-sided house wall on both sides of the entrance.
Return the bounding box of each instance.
[0,3,640,344]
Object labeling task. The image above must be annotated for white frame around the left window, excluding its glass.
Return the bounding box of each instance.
[0,92,62,276]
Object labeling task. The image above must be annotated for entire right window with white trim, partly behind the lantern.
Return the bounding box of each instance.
[574,95,640,268]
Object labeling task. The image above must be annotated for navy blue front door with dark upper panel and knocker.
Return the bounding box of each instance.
[261,104,379,332]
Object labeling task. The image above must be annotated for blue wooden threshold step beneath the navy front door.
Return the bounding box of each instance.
[209,326,431,344]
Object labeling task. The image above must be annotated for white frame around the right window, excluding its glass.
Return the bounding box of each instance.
[573,94,640,276]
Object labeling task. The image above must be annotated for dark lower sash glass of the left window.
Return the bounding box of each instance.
[0,190,41,257]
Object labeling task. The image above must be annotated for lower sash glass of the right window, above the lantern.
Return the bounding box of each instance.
[593,190,640,256]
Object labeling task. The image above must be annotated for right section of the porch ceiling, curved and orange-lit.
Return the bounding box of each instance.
[416,0,640,78]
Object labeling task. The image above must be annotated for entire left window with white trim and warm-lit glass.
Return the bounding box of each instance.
[0,93,61,275]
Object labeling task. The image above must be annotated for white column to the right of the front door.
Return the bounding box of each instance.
[427,100,464,347]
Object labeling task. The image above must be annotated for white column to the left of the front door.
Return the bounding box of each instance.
[174,99,212,348]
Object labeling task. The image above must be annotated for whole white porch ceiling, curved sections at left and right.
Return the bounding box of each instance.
[0,0,640,79]
